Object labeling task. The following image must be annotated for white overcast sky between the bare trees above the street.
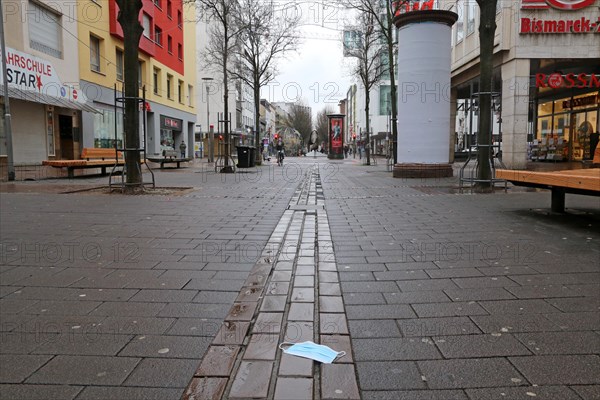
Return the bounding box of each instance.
[261,0,353,117]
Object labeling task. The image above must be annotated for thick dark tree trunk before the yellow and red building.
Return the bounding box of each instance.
[117,0,144,188]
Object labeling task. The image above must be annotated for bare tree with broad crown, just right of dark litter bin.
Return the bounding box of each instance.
[230,0,300,164]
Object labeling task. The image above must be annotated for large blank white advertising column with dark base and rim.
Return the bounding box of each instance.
[394,9,458,178]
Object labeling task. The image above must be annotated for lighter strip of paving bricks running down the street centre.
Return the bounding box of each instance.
[183,166,360,400]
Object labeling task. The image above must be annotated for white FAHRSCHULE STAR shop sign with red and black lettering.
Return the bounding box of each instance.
[0,48,87,103]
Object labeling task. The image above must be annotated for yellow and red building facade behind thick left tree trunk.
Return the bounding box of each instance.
[77,0,196,156]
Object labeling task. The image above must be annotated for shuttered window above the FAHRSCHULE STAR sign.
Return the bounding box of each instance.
[26,1,62,58]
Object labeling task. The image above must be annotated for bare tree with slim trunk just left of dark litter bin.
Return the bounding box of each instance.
[186,0,243,172]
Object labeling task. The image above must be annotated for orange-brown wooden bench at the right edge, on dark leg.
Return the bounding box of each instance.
[496,168,600,213]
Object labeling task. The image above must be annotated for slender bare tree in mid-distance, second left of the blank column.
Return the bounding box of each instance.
[351,12,387,165]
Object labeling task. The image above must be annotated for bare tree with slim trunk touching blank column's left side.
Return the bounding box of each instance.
[348,0,407,164]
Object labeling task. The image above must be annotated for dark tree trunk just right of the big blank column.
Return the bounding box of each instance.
[475,0,497,192]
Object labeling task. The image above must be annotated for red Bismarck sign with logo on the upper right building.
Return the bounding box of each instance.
[519,0,600,34]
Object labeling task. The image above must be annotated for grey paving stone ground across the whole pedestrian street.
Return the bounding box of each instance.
[0,158,600,400]
